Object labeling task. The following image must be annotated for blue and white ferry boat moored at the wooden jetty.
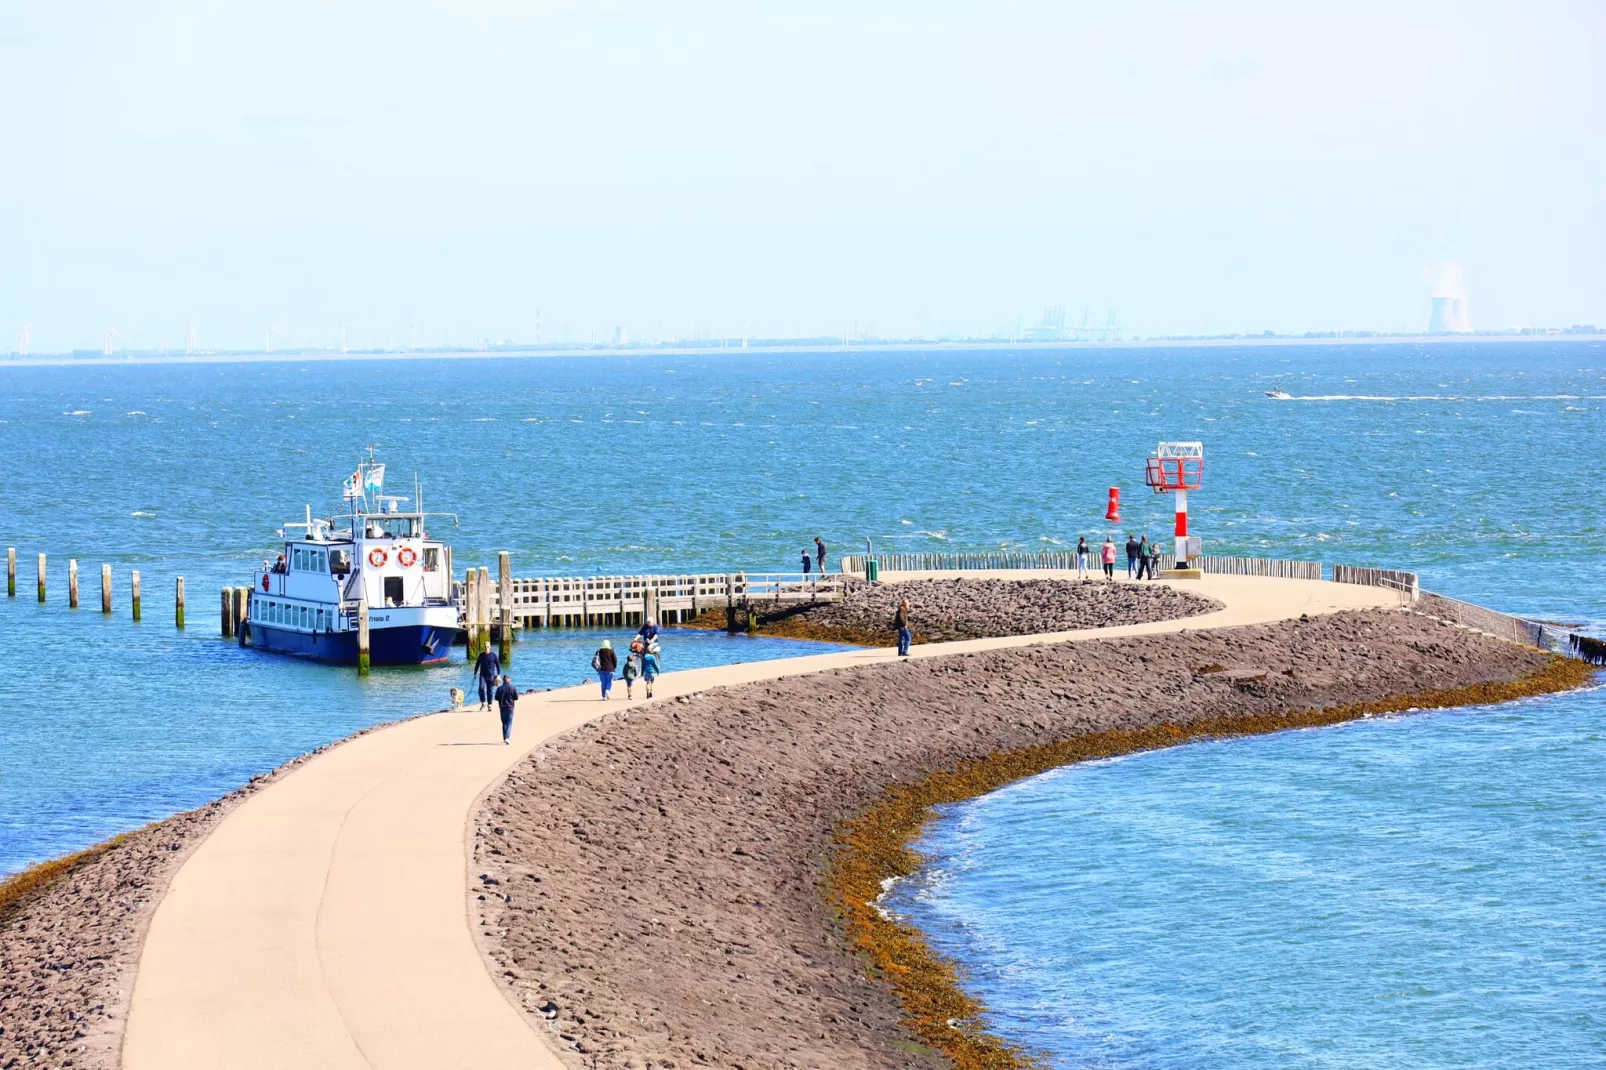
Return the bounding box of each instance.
[241,450,458,665]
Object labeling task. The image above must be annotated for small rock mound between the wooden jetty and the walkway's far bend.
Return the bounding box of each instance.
[680,577,1221,646]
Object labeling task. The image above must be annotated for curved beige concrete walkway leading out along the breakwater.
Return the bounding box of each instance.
[122,570,1399,1070]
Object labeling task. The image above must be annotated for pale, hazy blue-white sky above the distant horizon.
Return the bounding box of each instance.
[0,0,1606,353]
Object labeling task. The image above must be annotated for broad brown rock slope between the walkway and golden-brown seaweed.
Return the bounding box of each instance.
[472,611,1580,1070]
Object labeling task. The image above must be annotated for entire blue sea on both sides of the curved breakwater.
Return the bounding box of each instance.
[0,339,1606,1067]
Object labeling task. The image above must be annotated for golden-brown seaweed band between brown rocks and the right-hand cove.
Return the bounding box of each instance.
[822,655,1598,1070]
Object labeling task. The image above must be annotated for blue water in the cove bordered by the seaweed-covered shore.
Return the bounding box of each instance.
[893,691,1606,1070]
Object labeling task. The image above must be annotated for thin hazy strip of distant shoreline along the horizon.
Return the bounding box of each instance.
[0,334,1606,368]
